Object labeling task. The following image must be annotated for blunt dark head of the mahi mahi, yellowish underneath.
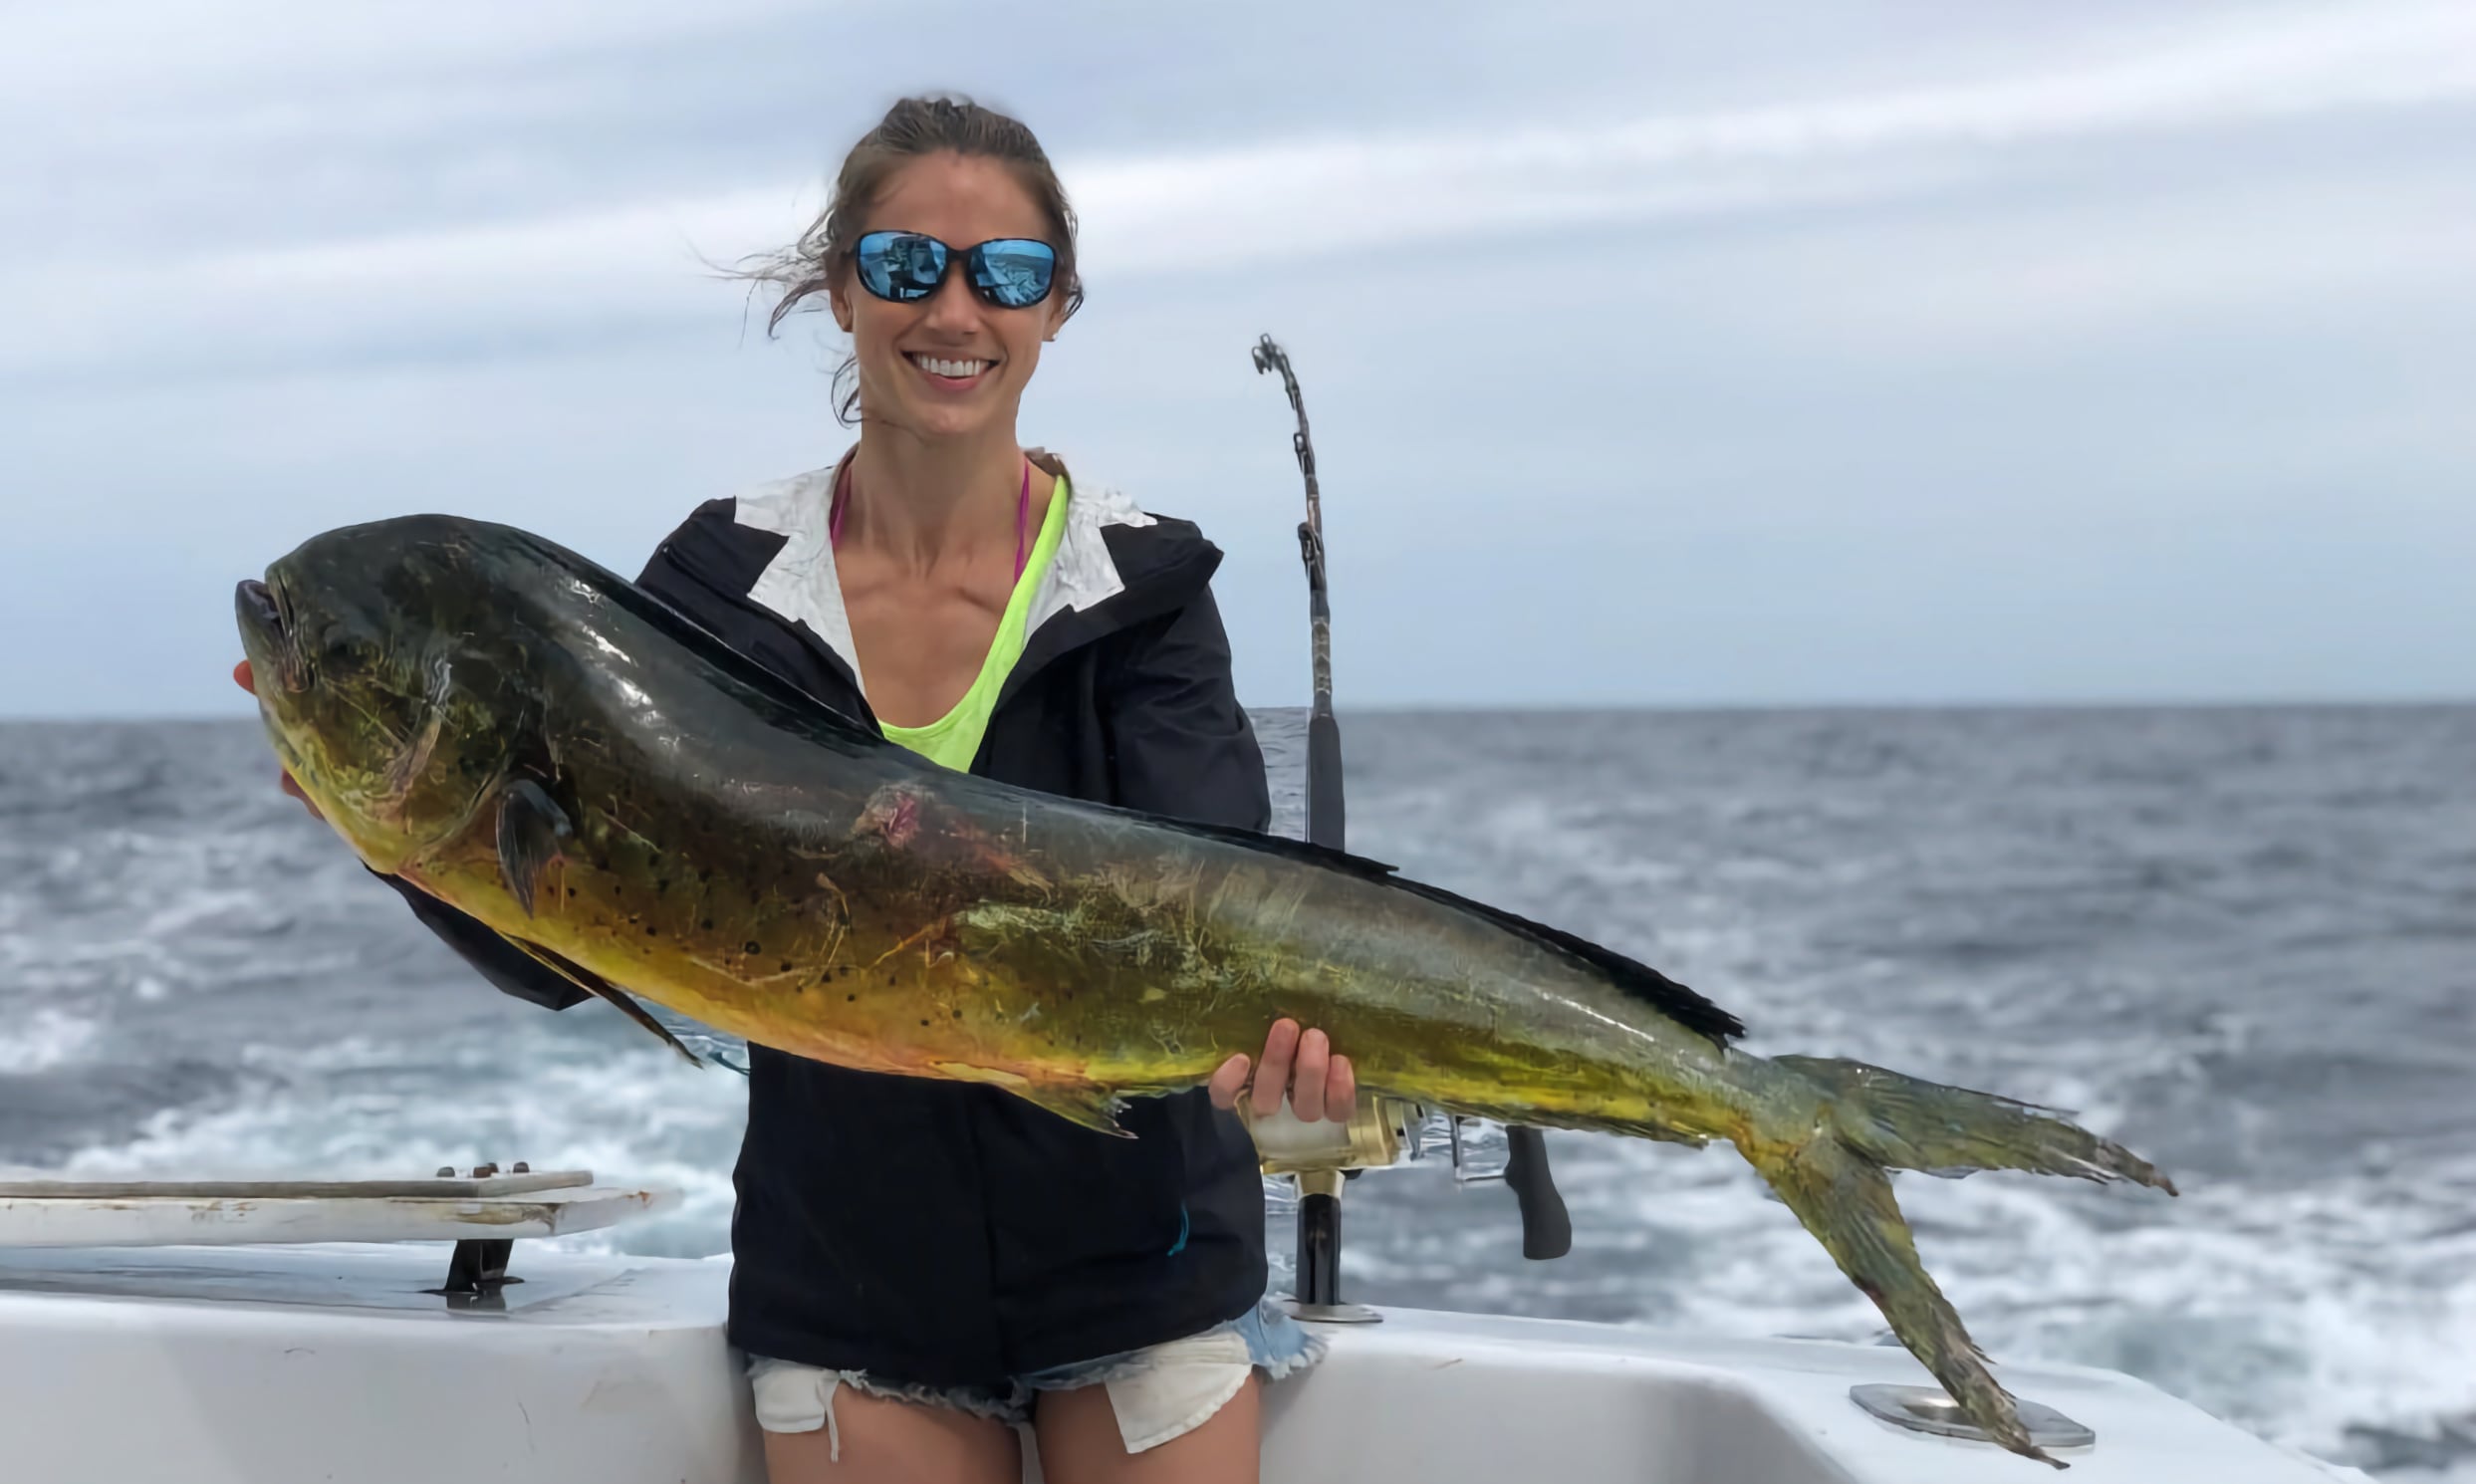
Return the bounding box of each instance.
[233,515,537,874]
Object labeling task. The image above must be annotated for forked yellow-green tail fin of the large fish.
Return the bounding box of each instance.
[1741,1056,2174,1469]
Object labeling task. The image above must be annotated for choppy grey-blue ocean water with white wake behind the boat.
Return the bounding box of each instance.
[0,708,2476,1482]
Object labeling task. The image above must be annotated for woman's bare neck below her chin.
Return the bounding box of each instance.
[842,426,1023,573]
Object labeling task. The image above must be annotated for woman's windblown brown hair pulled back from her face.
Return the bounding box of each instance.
[740,97,1082,426]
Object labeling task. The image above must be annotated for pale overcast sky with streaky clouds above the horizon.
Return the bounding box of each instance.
[0,0,2476,716]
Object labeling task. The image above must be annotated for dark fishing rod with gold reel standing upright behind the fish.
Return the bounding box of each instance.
[1253,335,1573,1321]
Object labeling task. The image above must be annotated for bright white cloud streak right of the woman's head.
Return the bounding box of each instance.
[1075,5,2476,268]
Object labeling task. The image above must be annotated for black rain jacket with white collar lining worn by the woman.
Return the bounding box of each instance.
[393,458,1270,1385]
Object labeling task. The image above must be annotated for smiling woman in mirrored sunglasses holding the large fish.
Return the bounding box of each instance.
[235,99,1357,1484]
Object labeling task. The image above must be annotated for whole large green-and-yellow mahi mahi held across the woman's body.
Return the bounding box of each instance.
[235,515,2174,1467]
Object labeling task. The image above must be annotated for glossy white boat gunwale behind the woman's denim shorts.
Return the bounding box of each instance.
[0,1244,2354,1484]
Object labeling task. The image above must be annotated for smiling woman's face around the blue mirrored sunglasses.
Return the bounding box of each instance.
[832,153,1065,453]
